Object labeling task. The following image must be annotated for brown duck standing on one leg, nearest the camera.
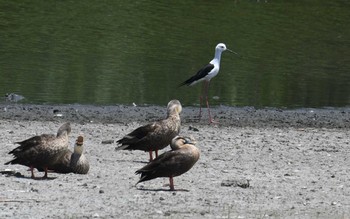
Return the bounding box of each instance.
[136,136,200,190]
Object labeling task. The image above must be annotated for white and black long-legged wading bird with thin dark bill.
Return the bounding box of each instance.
[179,43,238,123]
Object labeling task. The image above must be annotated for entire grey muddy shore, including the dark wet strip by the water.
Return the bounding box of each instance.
[0,103,350,218]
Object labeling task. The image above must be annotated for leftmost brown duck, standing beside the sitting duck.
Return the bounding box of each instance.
[5,123,71,178]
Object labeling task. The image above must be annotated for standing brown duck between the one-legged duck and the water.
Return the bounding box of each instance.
[116,100,182,160]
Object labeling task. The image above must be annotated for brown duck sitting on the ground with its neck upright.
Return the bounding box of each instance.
[48,136,90,174]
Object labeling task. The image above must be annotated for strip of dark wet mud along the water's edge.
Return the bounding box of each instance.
[0,103,350,128]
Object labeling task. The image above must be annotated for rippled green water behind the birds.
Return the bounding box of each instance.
[0,0,350,107]
